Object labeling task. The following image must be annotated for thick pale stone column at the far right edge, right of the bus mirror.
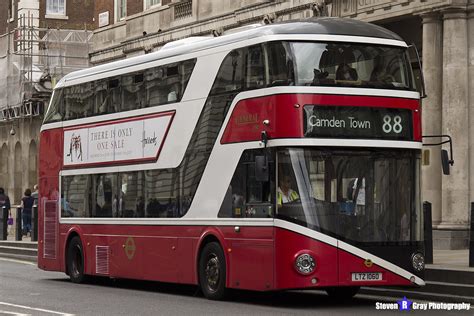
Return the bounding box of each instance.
[438,9,470,249]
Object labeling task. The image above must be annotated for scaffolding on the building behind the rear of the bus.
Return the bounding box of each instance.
[0,14,92,121]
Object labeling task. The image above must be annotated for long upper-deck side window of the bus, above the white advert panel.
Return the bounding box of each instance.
[44,59,196,123]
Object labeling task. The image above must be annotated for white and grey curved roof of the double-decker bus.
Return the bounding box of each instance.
[58,17,403,86]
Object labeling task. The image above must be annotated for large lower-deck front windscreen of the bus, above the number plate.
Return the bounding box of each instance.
[276,148,423,244]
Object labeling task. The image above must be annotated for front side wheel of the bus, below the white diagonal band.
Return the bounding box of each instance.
[199,242,227,300]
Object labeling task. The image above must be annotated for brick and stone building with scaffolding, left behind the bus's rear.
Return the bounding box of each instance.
[0,0,94,204]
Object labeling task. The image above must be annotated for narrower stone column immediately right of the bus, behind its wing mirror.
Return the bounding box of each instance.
[421,12,443,226]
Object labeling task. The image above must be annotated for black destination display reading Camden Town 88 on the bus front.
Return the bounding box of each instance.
[304,105,413,140]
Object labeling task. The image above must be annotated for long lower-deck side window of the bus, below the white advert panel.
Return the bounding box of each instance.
[61,169,182,218]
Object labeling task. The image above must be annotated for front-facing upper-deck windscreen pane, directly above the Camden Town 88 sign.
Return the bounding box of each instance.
[290,42,415,90]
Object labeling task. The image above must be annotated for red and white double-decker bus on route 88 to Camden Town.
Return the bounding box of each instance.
[38,18,424,299]
